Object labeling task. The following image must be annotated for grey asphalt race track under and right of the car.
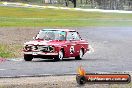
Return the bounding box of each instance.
[0,27,132,77]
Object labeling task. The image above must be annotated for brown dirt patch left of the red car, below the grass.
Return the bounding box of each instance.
[0,27,42,45]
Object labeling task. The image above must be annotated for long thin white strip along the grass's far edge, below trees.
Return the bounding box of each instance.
[0,2,132,13]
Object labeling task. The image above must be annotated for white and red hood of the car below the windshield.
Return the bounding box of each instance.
[24,40,65,46]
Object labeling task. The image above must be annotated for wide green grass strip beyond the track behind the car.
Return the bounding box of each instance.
[0,7,132,27]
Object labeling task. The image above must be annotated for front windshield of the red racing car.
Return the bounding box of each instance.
[36,30,66,40]
